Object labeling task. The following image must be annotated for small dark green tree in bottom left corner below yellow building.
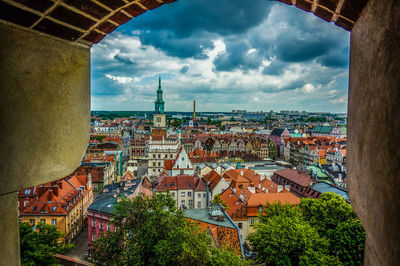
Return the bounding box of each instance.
[19,223,74,265]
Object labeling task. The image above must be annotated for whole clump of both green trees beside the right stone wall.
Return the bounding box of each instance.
[248,193,365,265]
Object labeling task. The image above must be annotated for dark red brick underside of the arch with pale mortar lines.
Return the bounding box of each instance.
[0,0,367,46]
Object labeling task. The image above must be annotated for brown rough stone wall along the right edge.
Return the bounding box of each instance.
[348,0,400,265]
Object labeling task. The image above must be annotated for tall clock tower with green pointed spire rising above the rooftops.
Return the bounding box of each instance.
[151,77,167,140]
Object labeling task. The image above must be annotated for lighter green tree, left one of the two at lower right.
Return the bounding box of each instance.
[248,215,340,265]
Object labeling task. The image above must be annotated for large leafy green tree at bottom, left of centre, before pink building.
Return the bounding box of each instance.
[92,194,242,265]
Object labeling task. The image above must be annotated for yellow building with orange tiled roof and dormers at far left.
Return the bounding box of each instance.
[18,170,93,242]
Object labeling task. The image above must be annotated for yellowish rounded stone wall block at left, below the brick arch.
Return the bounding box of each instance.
[0,24,90,195]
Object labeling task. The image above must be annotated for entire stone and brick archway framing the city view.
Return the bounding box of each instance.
[0,0,400,265]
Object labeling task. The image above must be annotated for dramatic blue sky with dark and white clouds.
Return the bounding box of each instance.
[91,0,350,112]
